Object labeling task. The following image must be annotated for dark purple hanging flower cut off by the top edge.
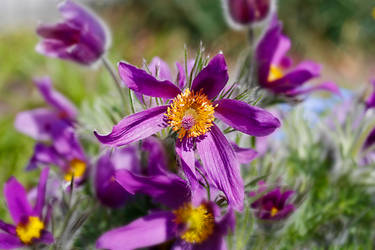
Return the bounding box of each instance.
[223,0,275,28]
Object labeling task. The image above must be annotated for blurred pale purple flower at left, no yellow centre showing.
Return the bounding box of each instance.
[14,77,77,141]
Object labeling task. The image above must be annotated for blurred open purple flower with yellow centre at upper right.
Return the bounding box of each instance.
[255,16,339,97]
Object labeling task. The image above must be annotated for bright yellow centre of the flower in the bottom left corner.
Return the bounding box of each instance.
[16,216,44,244]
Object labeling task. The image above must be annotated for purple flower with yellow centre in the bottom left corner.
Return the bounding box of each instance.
[0,168,54,249]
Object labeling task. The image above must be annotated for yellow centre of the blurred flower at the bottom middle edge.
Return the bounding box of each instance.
[173,203,215,243]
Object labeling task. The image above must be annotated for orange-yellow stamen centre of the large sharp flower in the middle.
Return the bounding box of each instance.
[166,89,215,140]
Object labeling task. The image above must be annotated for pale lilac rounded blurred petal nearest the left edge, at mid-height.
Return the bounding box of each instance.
[14,108,59,140]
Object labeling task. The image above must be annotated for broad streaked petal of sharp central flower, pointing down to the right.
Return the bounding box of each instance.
[197,124,244,210]
